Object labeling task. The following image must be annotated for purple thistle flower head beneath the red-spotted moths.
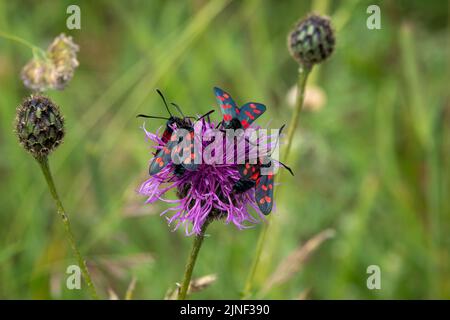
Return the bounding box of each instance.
[138,120,270,235]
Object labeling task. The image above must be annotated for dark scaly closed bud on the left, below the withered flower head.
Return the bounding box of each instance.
[16,95,64,159]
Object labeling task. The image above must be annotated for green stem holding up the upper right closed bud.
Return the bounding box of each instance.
[241,66,312,299]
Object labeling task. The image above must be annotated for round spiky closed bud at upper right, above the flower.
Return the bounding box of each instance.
[288,14,335,66]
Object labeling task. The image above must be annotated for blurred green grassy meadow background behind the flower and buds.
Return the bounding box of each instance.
[0,0,450,299]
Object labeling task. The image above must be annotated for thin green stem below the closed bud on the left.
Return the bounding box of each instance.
[37,157,98,300]
